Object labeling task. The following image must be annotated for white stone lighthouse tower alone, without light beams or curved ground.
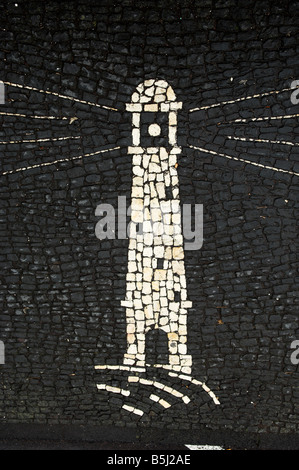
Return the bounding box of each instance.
[121,80,192,373]
